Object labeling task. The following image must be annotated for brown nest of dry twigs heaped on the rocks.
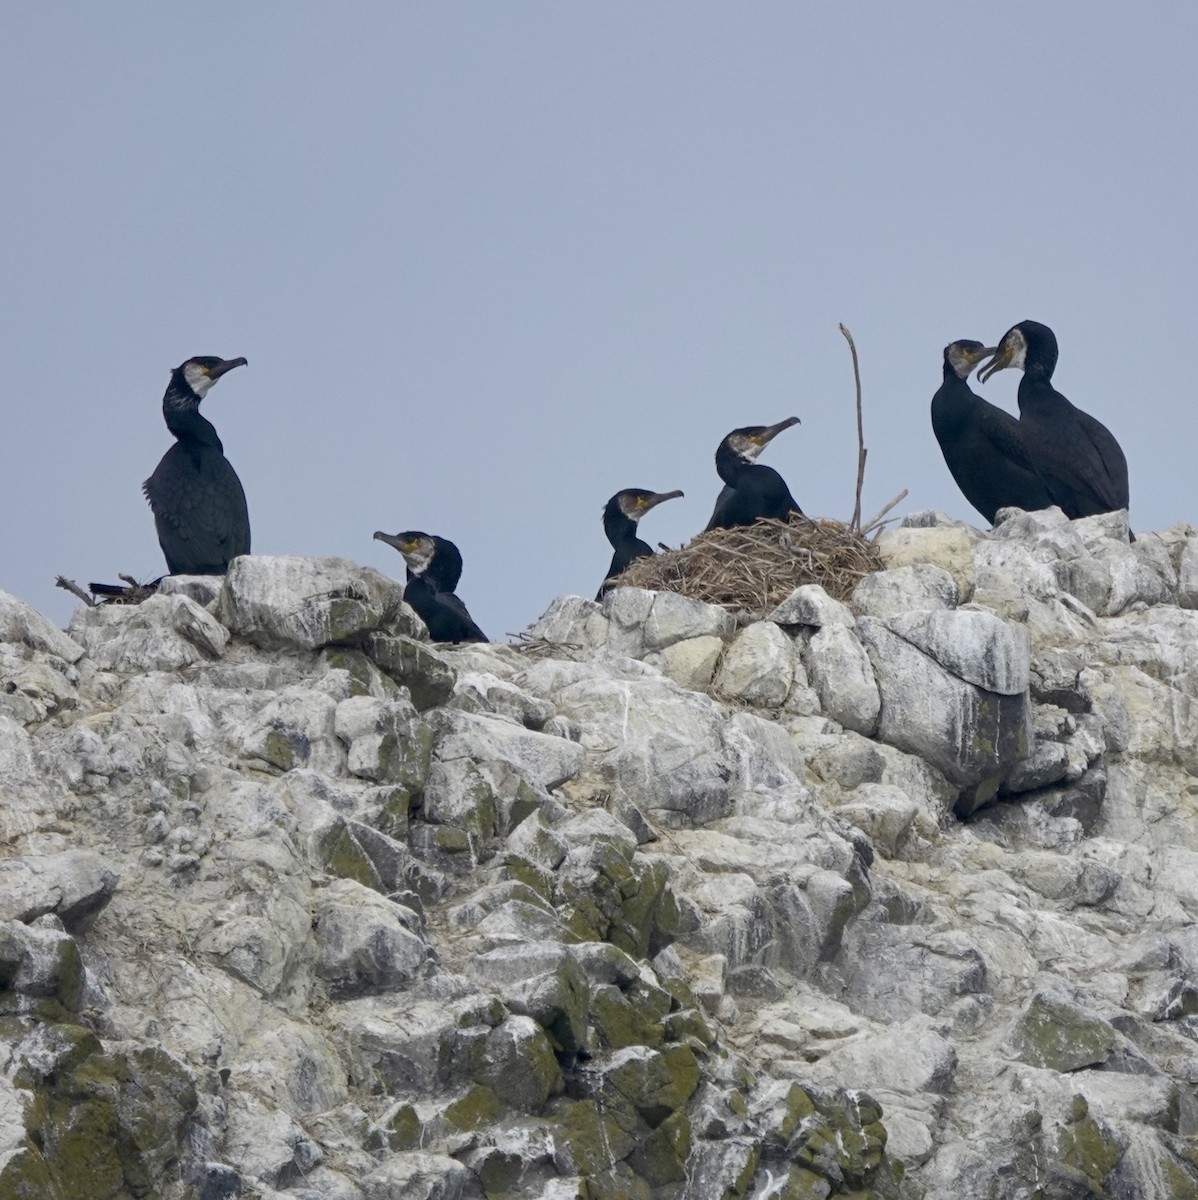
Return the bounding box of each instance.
[611,516,885,617]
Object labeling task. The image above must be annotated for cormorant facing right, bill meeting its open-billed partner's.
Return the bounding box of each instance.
[932,340,1053,524]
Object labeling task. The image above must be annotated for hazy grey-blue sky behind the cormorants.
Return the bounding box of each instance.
[0,0,1198,640]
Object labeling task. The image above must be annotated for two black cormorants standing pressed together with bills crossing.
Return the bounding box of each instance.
[932,320,1128,524]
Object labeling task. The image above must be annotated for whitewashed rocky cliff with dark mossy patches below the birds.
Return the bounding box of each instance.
[0,510,1198,1200]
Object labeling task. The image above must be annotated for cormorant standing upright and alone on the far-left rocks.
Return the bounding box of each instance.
[142,355,250,575]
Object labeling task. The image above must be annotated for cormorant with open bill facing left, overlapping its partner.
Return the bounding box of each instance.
[977,320,1128,518]
